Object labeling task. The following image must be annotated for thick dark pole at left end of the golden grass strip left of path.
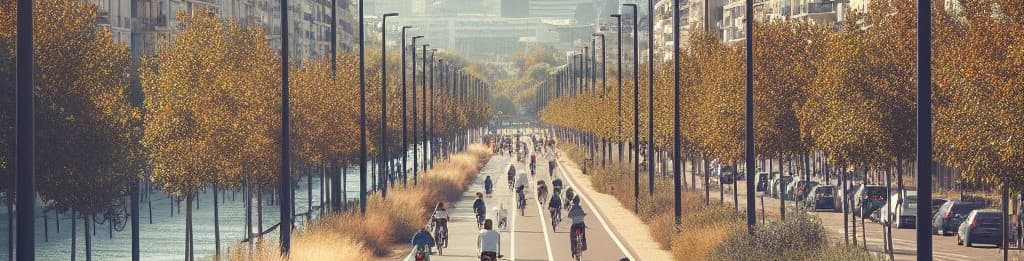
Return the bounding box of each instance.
[278,0,290,252]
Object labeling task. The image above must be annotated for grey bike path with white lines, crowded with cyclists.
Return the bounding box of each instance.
[406,129,635,260]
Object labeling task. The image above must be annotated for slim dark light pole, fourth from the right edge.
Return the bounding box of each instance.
[646,0,655,197]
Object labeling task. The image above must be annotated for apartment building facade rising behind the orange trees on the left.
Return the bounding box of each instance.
[85,0,355,61]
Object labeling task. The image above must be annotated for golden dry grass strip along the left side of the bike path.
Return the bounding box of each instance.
[229,144,490,261]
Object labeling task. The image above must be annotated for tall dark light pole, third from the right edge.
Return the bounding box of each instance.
[672,0,684,228]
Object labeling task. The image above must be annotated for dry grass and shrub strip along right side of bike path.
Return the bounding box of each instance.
[559,144,873,260]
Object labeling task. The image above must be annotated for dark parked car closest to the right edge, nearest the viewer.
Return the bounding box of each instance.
[956,209,1002,247]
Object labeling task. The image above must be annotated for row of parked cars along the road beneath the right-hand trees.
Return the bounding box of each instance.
[756,172,1002,247]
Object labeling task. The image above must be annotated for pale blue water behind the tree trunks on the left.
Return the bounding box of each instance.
[0,144,432,260]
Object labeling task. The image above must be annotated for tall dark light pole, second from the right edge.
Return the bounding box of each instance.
[743,0,757,233]
